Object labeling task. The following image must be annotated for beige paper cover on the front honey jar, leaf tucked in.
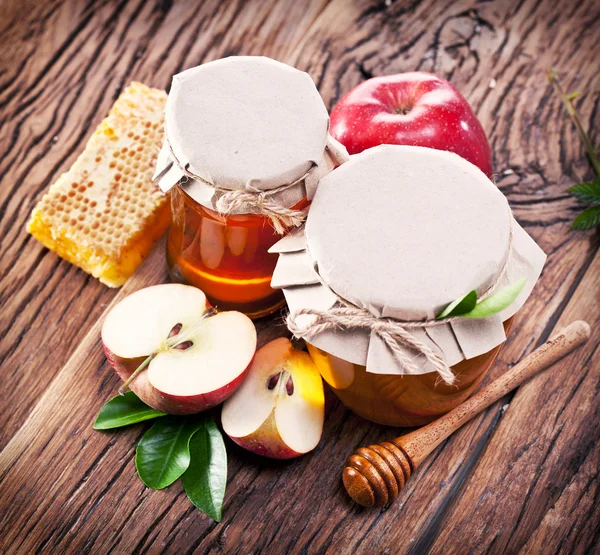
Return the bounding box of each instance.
[272,145,545,374]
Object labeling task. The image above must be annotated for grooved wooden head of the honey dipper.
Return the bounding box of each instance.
[342,443,411,507]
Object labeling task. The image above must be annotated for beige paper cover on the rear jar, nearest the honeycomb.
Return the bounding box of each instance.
[155,56,347,213]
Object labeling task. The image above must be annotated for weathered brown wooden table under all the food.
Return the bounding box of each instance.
[0,0,600,553]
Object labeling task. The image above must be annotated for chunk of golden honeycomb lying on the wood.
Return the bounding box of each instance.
[27,82,170,287]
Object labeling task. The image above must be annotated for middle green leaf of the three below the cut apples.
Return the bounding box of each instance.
[135,416,204,489]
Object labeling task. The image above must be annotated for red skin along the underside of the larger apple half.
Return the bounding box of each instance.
[103,345,252,414]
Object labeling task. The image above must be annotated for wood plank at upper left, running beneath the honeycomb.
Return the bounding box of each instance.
[0,0,327,447]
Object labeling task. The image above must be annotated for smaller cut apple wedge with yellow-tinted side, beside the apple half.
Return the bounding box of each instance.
[221,338,325,459]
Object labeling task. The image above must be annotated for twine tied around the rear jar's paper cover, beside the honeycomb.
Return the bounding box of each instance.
[165,139,308,235]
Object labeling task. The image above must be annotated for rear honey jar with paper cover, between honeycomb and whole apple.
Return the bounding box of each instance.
[154,56,347,317]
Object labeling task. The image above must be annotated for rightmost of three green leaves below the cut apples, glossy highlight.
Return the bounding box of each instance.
[181,420,227,522]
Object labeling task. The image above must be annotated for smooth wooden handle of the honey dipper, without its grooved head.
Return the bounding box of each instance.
[392,320,591,468]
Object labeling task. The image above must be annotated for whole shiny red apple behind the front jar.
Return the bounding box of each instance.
[330,71,493,179]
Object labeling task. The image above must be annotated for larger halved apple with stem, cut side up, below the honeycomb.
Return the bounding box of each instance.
[102,283,256,414]
